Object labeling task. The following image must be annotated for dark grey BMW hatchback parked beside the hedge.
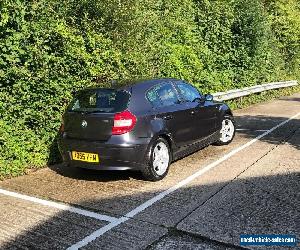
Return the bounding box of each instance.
[58,79,235,181]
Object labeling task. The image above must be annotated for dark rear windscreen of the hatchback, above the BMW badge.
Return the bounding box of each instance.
[68,89,130,113]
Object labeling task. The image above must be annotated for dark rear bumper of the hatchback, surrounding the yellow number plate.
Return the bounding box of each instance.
[58,136,151,170]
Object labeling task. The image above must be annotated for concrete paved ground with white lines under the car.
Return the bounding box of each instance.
[0,94,300,249]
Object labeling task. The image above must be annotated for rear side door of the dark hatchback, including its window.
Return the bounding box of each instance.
[146,82,192,147]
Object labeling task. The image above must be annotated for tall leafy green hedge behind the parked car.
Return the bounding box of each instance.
[0,0,300,176]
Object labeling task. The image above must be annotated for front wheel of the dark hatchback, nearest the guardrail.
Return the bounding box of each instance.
[215,115,235,145]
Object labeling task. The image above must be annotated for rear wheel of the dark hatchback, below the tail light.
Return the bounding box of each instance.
[142,138,171,181]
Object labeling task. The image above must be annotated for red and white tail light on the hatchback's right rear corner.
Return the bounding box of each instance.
[112,110,136,135]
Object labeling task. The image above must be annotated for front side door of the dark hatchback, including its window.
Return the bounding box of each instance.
[175,81,217,142]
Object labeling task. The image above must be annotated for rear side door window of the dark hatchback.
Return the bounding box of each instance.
[146,83,179,107]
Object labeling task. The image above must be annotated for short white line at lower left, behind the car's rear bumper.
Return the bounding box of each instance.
[0,188,118,222]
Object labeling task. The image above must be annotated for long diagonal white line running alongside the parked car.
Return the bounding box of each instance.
[68,112,300,250]
